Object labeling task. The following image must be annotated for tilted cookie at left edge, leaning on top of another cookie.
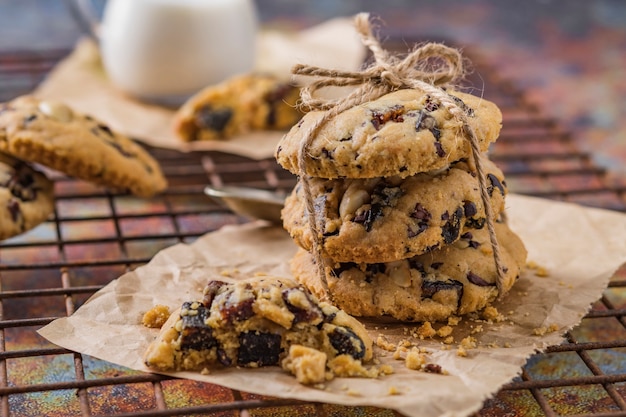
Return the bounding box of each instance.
[0,96,167,197]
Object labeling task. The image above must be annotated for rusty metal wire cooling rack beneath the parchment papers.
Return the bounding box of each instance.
[0,50,626,417]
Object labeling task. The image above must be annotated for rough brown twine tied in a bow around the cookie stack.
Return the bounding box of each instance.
[291,13,505,301]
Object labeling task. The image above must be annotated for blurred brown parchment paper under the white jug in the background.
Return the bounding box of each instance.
[33,18,365,159]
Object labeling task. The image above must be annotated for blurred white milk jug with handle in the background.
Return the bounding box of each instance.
[75,0,257,105]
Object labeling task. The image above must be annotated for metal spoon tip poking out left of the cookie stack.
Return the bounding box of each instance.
[204,186,285,224]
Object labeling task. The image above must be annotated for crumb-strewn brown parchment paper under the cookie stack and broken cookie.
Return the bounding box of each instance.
[39,195,626,416]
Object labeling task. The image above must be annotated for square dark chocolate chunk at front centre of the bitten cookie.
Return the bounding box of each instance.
[237,331,282,366]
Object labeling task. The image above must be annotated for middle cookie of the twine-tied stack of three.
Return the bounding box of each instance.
[282,158,507,263]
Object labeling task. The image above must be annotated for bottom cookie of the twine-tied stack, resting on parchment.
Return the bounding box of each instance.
[291,223,526,321]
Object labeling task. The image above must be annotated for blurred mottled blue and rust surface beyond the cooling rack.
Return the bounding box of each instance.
[0,0,626,179]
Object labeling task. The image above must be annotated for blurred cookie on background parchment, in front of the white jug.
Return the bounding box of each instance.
[174,74,302,142]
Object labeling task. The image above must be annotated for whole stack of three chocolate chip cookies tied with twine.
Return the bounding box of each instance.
[276,89,526,321]
